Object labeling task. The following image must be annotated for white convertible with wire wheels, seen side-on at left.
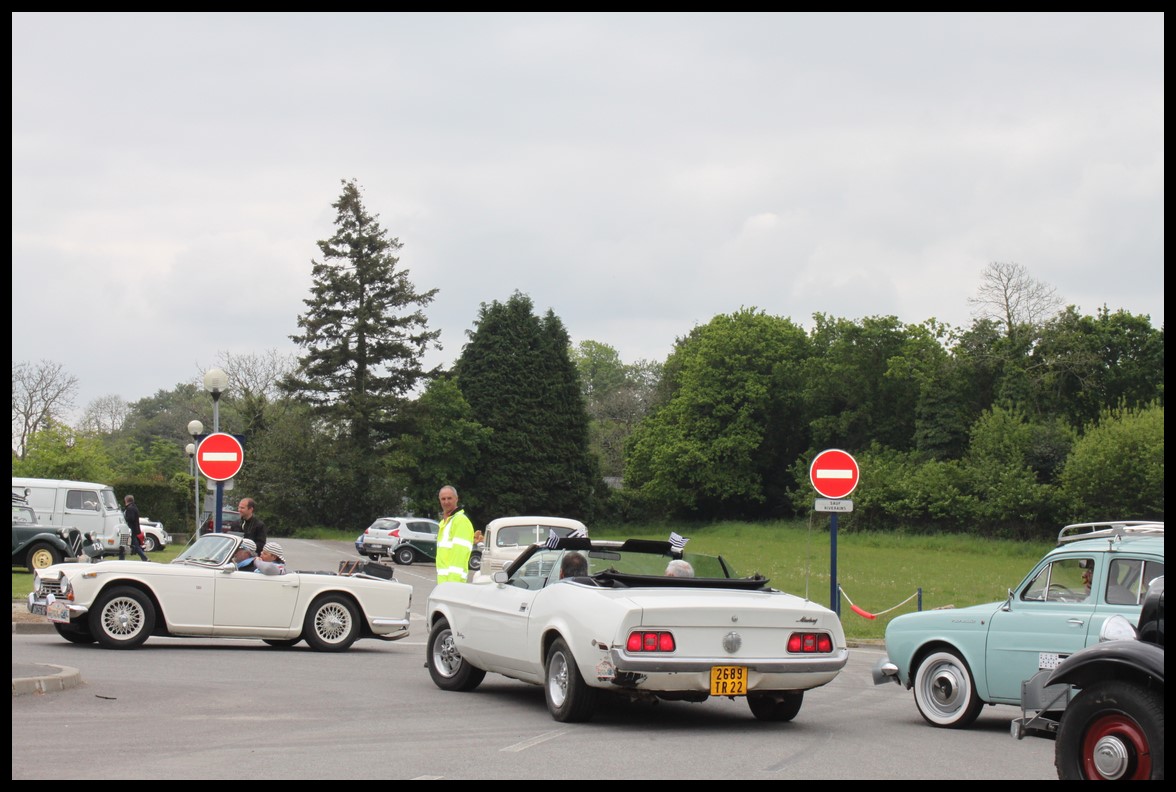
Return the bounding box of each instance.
[28,533,413,652]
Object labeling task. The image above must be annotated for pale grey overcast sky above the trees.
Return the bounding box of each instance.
[12,13,1164,418]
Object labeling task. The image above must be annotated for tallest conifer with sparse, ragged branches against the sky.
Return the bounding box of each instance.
[285,180,441,520]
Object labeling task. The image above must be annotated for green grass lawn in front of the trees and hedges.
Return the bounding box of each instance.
[12,518,1054,640]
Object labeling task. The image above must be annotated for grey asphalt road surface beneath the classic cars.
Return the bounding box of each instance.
[12,539,1056,780]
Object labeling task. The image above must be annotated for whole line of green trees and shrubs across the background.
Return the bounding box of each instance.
[13,181,1164,539]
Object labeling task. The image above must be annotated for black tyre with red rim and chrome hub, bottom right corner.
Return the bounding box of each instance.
[1054,679,1164,781]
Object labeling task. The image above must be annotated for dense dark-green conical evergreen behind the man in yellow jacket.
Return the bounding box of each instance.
[454,292,599,524]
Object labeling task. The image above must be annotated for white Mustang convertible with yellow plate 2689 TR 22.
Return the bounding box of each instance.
[426,535,849,721]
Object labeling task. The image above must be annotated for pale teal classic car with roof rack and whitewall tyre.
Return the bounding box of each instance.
[873,520,1164,728]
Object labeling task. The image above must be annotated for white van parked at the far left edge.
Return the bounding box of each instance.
[12,475,131,555]
